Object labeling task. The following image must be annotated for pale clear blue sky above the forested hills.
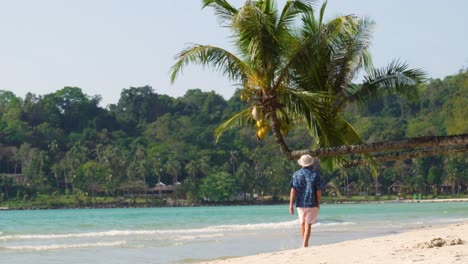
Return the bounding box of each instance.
[0,0,468,106]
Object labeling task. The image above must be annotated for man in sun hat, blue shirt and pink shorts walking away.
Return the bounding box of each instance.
[289,155,323,247]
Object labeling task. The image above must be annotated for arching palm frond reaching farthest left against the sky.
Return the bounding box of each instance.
[171,45,247,82]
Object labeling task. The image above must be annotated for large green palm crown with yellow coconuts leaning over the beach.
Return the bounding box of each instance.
[171,0,423,169]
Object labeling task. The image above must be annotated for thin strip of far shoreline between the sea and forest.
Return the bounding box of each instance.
[0,198,468,211]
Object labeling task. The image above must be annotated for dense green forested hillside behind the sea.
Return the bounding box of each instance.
[0,71,468,206]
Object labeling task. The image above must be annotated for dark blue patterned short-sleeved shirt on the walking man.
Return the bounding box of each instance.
[291,167,323,207]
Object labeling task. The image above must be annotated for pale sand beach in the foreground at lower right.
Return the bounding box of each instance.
[206,222,468,264]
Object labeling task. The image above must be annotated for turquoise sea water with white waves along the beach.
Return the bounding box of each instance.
[0,202,468,264]
